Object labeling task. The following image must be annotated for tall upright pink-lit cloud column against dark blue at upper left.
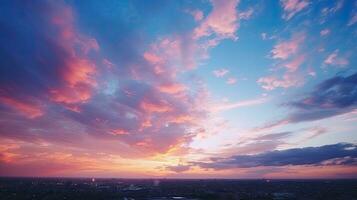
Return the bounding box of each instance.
[49,6,99,108]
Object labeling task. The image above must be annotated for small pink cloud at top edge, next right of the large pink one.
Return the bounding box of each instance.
[280,0,310,20]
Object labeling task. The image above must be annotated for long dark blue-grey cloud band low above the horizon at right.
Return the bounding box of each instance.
[193,143,357,170]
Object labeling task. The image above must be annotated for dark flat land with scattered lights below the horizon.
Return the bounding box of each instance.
[0,178,357,200]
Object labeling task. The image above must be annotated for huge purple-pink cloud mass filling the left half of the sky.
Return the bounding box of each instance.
[0,1,208,157]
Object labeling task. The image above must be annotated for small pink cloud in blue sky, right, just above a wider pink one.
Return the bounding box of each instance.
[271,33,305,60]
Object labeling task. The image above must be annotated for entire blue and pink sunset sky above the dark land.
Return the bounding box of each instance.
[0,0,357,179]
